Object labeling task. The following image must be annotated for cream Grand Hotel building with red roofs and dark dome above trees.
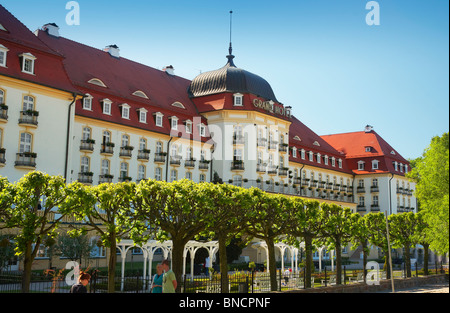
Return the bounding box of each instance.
[0,5,417,268]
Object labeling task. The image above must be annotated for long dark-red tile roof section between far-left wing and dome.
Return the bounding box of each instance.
[38,31,209,141]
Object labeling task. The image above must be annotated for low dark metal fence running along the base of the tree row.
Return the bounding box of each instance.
[0,264,449,293]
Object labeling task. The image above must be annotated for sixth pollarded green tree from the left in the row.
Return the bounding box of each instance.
[287,197,324,288]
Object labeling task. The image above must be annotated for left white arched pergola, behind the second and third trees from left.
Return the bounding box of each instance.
[117,240,219,290]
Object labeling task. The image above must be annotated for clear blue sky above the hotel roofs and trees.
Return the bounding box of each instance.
[1,0,449,158]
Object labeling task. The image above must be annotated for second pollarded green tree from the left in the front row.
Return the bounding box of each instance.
[69,182,136,293]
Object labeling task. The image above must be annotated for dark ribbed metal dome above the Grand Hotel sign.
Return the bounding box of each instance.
[189,54,278,102]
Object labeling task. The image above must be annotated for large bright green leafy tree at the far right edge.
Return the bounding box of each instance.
[407,133,449,254]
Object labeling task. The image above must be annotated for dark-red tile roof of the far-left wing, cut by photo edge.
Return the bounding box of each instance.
[0,5,78,93]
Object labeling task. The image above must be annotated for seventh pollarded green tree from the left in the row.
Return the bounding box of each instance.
[320,203,359,285]
